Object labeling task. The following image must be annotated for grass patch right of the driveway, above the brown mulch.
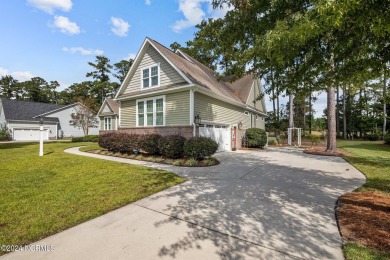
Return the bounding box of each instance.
[337,141,390,193]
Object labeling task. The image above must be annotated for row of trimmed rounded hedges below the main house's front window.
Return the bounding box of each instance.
[98,132,218,160]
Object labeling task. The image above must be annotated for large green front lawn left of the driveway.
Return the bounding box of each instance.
[0,142,184,255]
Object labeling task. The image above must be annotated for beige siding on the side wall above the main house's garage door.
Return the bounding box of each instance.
[194,92,250,129]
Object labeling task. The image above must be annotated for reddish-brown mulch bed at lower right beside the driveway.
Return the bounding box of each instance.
[336,191,390,252]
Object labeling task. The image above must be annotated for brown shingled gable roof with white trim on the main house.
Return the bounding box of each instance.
[115,37,262,111]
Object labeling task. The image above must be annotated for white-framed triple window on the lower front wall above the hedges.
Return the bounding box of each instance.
[136,96,165,126]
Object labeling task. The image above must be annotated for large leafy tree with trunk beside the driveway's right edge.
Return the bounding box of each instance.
[213,0,390,152]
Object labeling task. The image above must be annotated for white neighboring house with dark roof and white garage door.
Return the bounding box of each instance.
[0,99,99,141]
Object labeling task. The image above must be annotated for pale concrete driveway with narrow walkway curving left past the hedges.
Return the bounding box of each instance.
[1,148,365,260]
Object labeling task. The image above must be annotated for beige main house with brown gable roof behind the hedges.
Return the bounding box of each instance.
[99,38,266,150]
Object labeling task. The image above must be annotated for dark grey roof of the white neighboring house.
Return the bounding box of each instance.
[1,99,64,121]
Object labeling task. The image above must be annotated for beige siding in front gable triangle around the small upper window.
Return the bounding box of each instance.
[124,46,186,94]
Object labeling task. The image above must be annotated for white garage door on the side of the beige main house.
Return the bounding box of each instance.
[199,124,231,151]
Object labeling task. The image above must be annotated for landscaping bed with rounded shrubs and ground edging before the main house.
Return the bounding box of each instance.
[92,131,219,167]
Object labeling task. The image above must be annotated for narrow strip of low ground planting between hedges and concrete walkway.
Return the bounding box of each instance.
[87,149,219,167]
